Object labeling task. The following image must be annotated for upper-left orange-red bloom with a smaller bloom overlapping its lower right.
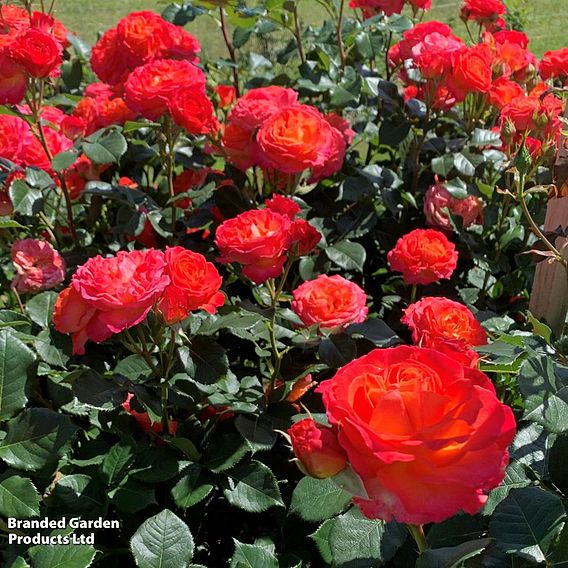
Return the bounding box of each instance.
[124,59,205,120]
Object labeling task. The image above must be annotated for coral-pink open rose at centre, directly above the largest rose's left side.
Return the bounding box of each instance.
[292,274,368,329]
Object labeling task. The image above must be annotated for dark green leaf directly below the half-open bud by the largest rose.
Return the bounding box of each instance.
[290,477,351,522]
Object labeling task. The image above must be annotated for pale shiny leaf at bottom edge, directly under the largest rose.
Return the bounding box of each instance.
[329,508,407,568]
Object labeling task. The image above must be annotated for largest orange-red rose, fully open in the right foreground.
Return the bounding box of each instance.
[318,346,515,524]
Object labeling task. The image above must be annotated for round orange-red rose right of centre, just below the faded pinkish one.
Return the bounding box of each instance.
[387,229,458,284]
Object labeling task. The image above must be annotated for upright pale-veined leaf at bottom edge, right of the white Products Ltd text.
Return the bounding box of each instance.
[130,509,193,568]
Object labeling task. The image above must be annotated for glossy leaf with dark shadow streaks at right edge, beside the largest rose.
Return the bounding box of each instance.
[518,355,568,432]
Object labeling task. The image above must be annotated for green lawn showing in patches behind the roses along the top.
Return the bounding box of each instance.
[52,0,568,57]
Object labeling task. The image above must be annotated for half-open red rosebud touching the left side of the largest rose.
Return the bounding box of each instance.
[288,418,347,479]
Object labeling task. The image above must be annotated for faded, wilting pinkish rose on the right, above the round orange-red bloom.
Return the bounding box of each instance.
[424,183,483,231]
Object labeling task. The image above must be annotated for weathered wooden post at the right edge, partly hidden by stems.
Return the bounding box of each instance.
[529,126,568,337]
